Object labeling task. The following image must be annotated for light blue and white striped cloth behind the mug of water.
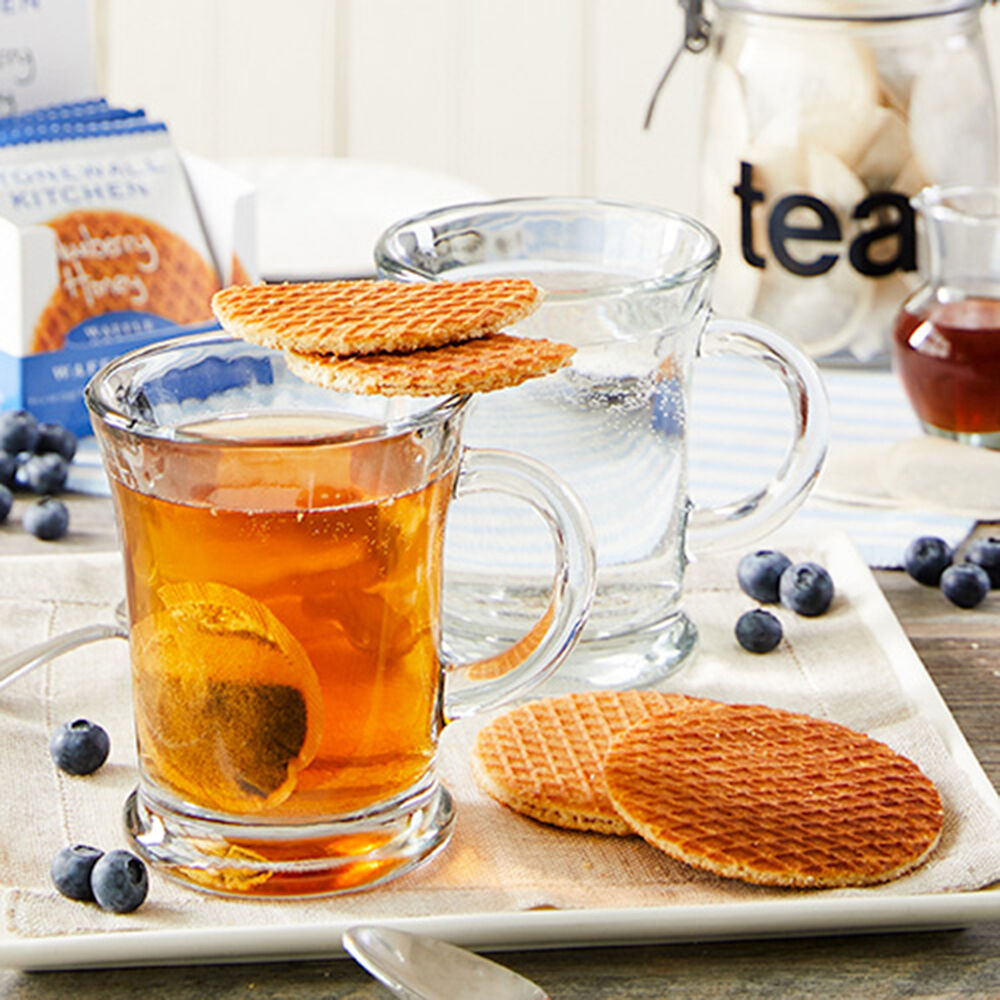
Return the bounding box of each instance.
[689,358,973,568]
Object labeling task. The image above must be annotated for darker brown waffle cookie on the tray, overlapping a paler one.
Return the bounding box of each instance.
[604,705,943,888]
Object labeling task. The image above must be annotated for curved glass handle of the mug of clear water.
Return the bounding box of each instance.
[688,319,830,552]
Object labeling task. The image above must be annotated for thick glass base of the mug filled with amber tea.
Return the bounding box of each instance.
[125,781,455,898]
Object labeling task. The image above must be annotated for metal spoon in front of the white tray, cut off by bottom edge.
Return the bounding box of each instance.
[342,926,549,1000]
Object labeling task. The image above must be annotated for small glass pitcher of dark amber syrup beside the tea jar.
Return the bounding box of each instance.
[893,185,1000,448]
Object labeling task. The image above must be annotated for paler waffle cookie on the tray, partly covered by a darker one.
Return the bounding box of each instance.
[472,691,710,836]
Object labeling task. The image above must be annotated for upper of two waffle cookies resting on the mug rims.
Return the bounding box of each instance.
[212,278,542,356]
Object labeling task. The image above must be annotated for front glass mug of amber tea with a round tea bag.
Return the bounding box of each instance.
[85,333,594,896]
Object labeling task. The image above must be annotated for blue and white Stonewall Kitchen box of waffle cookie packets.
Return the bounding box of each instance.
[0,146,256,435]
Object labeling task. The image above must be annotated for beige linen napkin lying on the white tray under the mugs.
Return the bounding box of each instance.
[0,538,1000,943]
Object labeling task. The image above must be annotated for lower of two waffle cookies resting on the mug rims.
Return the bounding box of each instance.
[285,333,576,396]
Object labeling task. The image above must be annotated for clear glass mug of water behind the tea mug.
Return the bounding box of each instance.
[375,198,829,691]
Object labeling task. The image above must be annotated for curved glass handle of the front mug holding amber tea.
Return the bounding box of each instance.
[444,448,597,721]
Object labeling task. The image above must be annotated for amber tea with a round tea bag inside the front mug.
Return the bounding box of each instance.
[113,414,453,821]
